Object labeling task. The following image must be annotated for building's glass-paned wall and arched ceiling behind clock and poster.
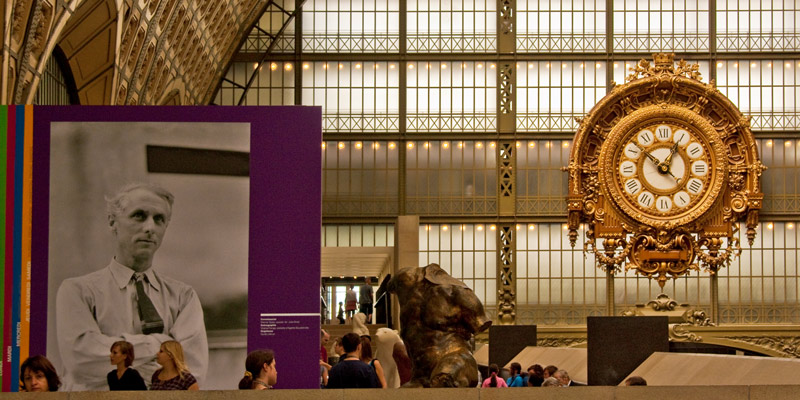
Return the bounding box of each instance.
[6,0,800,357]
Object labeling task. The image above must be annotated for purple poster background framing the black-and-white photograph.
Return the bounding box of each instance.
[30,106,322,389]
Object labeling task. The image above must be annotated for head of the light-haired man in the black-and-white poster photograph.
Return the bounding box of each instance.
[106,183,175,272]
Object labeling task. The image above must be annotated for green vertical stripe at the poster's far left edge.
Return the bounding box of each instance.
[0,106,6,391]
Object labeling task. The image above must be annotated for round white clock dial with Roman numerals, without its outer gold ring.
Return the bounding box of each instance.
[613,123,714,218]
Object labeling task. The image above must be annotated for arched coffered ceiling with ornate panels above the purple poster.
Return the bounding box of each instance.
[0,0,267,104]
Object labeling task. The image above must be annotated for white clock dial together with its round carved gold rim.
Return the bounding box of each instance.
[598,104,727,229]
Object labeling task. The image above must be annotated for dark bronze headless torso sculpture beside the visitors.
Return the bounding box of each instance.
[388,264,492,387]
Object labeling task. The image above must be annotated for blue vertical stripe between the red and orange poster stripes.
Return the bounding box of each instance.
[9,106,25,392]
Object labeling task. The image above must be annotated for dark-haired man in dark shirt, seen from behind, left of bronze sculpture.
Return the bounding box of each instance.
[326,332,381,389]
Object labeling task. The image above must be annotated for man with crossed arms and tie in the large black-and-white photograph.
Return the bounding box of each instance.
[56,184,208,391]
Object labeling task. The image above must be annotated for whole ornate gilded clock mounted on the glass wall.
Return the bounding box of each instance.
[567,54,764,294]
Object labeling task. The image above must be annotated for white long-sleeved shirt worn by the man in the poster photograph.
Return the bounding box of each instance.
[56,260,208,391]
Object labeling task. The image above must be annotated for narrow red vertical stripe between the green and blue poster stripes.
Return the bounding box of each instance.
[3,106,17,392]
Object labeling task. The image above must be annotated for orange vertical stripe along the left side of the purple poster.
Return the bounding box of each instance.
[19,104,33,368]
